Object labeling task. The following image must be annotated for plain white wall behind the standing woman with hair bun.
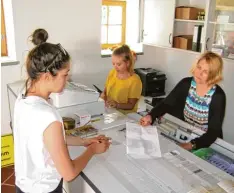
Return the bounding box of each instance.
[1,0,112,134]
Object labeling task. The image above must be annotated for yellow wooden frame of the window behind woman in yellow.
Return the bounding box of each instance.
[101,0,126,49]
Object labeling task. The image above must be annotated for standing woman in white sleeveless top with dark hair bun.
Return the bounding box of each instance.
[13,29,109,193]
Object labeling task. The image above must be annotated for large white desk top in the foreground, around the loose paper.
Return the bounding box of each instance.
[8,80,234,193]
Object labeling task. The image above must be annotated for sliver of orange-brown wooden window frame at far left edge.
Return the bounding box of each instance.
[1,1,8,56]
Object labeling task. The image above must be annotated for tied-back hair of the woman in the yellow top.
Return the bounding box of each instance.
[112,44,135,73]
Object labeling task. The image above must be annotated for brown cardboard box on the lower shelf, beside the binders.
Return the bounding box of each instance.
[173,35,193,50]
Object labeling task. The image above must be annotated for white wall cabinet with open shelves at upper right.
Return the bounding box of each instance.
[142,0,234,59]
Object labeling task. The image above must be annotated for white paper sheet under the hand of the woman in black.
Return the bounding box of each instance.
[126,122,161,159]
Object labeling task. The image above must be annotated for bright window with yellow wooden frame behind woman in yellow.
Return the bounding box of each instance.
[101,0,126,49]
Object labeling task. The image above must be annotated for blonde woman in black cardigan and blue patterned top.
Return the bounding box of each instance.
[141,52,226,150]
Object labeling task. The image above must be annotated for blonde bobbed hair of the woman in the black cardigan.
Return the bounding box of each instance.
[190,51,223,85]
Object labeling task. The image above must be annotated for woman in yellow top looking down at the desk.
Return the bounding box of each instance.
[101,45,142,114]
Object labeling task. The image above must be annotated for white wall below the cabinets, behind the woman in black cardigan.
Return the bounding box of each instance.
[138,45,234,144]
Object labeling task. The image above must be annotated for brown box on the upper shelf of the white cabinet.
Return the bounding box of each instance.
[175,6,204,20]
